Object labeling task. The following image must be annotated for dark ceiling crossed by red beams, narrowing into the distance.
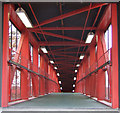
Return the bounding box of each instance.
[15,2,107,92]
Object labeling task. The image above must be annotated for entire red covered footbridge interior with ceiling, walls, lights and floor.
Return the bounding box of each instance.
[2,2,119,109]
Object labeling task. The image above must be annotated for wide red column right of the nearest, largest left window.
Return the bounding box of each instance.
[21,33,30,99]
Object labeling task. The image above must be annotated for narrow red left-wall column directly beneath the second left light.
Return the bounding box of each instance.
[40,55,45,95]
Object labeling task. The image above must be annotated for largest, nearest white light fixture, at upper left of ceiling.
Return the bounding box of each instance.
[16,7,33,28]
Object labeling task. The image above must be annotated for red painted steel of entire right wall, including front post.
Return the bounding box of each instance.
[75,4,119,108]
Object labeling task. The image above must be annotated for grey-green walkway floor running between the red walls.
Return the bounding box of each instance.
[9,93,110,109]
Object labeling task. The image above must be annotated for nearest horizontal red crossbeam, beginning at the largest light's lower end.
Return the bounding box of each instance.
[28,27,96,32]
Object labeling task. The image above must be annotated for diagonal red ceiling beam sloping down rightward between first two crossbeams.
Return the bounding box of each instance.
[33,31,80,42]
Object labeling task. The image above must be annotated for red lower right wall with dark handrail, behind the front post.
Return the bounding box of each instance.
[76,49,112,102]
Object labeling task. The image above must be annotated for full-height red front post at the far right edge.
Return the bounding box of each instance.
[111,3,119,108]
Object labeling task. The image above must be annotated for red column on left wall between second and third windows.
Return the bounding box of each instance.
[32,46,39,97]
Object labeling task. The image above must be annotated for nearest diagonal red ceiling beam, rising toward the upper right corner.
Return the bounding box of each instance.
[34,3,108,27]
